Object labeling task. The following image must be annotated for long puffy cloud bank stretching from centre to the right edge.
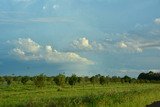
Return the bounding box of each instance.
[71,36,160,53]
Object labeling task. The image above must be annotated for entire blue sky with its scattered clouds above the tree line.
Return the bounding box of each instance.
[0,0,160,77]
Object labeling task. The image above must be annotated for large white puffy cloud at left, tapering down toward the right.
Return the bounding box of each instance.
[12,38,94,64]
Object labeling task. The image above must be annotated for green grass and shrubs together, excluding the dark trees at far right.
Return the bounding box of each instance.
[0,70,160,107]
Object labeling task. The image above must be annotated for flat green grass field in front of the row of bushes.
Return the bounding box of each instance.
[0,83,160,107]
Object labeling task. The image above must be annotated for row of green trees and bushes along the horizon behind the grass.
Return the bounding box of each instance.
[0,71,160,87]
